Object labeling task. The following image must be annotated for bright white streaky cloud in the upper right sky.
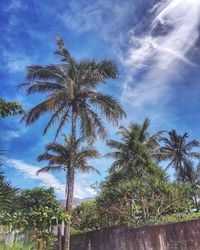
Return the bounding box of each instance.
[122,0,200,109]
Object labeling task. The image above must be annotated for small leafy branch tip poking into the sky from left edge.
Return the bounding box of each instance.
[0,99,25,118]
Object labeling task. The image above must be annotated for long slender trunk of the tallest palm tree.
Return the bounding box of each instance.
[64,109,76,250]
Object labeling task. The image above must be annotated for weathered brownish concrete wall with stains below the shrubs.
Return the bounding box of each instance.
[71,220,200,250]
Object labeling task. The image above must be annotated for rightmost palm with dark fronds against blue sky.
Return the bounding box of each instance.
[155,130,200,179]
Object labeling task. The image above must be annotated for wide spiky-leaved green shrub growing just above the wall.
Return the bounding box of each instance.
[97,165,192,225]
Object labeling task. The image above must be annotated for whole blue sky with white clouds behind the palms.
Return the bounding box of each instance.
[0,0,200,197]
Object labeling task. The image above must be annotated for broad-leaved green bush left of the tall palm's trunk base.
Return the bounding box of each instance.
[0,188,68,247]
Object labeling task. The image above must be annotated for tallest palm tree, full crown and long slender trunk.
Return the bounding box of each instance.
[23,37,125,249]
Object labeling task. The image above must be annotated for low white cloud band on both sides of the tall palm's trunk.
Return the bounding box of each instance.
[6,159,96,199]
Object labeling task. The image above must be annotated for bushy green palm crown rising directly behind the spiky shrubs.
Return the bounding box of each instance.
[106,119,161,172]
